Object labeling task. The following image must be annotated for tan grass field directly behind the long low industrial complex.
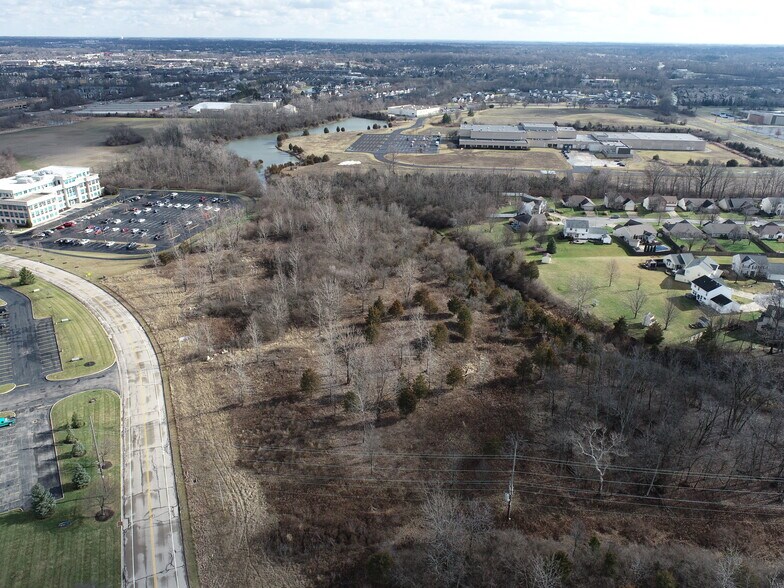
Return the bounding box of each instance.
[473,105,666,127]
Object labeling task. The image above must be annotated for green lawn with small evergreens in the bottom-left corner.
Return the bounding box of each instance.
[0,390,121,588]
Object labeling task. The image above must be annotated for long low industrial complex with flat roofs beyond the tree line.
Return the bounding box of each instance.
[458,122,705,158]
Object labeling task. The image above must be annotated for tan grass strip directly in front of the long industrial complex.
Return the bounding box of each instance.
[395,147,569,171]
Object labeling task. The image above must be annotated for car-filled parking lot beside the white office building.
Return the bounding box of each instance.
[19,190,240,253]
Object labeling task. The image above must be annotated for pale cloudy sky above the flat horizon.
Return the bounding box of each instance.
[0,0,784,45]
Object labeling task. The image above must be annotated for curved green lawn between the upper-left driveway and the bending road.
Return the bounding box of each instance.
[0,270,115,380]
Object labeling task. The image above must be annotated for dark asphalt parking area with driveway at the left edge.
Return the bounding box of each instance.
[0,286,116,512]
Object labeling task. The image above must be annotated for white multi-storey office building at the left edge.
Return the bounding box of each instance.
[0,165,103,227]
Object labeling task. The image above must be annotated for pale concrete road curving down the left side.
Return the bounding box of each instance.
[0,254,187,588]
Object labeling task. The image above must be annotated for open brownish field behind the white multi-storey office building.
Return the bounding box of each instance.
[0,117,179,168]
